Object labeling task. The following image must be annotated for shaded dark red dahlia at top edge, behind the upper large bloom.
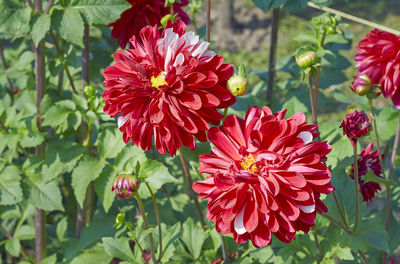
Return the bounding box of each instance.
[109,0,190,48]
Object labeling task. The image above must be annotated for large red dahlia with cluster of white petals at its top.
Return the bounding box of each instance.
[103,21,235,155]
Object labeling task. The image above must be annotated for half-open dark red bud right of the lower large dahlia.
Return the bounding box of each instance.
[340,109,371,146]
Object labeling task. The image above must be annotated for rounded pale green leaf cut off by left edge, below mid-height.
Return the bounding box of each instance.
[0,166,22,205]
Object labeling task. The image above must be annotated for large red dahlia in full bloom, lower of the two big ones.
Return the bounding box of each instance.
[193,107,334,247]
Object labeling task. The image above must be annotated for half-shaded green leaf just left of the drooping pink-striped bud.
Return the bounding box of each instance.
[94,167,117,213]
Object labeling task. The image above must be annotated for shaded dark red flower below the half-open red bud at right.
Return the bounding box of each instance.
[350,143,383,202]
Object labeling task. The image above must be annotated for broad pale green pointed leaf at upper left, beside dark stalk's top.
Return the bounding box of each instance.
[52,8,84,47]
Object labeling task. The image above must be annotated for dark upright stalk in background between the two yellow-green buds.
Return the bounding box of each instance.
[266,7,281,103]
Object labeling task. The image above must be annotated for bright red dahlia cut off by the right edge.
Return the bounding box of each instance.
[354,29,400,110]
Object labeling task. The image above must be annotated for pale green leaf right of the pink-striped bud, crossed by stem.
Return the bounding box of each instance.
[139,160,176,199]
